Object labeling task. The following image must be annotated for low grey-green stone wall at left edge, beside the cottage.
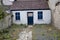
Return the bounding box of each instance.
[0,15,11,30]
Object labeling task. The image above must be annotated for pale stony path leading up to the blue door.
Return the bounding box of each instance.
[17,27,32,40]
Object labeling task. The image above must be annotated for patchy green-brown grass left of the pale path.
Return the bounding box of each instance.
[0,24,26,40]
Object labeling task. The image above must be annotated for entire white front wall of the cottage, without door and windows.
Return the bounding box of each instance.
[12,10,51,24]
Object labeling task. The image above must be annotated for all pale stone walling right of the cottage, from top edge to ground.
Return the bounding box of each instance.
[48,0,60,29]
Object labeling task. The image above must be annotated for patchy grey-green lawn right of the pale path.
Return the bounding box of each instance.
[32,25,60,40]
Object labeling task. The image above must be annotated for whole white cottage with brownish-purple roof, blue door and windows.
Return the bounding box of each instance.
[2,0,51,25]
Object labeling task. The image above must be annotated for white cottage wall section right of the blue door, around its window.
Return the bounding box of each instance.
[34,10,51,24]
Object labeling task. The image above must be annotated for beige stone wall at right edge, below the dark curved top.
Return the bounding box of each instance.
[53,5,60,29]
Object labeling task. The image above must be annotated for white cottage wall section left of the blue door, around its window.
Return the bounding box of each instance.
[12,11,27,24]
